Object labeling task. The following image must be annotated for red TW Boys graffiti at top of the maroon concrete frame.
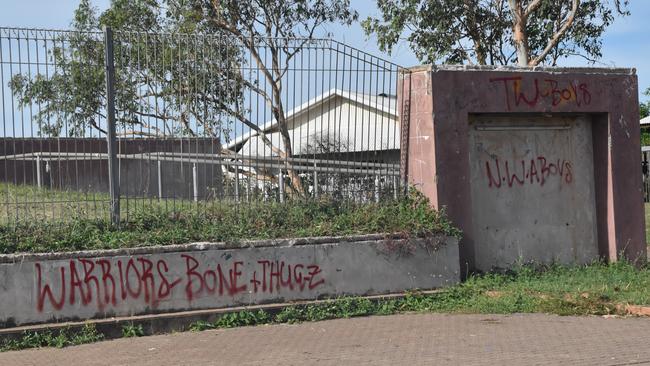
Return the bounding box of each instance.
[490,76,591,110]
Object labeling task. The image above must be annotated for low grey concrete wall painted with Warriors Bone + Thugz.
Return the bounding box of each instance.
[0,235,460,327]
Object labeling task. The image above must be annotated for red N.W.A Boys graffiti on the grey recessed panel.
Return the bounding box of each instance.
[485,156,573,188]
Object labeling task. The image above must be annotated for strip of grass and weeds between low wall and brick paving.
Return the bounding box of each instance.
[0,262,650,351]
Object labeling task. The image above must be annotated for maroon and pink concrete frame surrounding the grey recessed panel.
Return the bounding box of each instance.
[400,67,646,270]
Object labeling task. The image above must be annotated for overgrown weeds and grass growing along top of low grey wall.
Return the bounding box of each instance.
[0,191,459,253]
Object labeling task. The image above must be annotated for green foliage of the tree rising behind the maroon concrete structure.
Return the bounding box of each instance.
[362,0,629,65]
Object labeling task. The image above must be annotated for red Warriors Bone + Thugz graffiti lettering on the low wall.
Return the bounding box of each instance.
[34,254,325,311]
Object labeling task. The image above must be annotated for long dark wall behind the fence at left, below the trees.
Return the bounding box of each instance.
[0,138,223,199]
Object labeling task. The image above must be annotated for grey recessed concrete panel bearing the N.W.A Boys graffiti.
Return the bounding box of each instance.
[469,115,598,271]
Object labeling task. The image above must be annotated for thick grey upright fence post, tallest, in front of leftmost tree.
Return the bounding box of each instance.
[104,26,120,225]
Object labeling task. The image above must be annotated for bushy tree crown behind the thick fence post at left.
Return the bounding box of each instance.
[9,0,243,137]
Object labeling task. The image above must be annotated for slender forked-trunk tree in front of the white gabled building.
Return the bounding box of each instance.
[200,0,358,194]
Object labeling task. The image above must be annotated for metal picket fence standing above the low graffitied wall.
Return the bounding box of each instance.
[0,28,405,222]
